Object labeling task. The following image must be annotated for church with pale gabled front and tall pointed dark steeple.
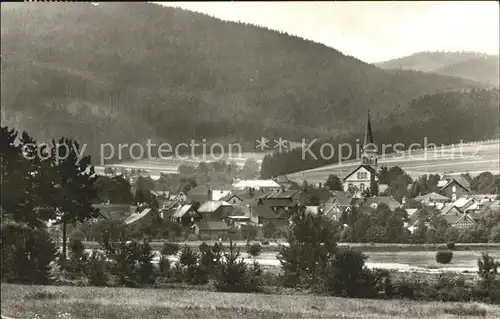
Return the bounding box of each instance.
[344,111,378,196]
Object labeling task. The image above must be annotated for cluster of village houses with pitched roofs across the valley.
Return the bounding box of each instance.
[92,176,499,237]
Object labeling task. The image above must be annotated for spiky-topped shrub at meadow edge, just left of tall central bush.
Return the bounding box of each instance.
[215,241,261,292]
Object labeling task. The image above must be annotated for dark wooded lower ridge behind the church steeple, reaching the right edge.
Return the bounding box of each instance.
[261,89,500,178]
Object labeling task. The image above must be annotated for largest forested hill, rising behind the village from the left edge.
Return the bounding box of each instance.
[1,2,482,162]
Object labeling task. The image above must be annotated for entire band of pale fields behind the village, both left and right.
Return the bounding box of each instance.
[96,140,500,183]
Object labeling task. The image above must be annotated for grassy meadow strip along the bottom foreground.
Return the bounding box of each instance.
[1,284,500,319]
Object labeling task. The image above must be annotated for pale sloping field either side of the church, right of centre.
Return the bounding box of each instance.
[288,140,500,183]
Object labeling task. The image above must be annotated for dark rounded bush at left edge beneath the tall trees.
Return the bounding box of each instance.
[1,222,57,284]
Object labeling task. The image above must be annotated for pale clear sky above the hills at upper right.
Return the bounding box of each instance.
[156,1,500,63]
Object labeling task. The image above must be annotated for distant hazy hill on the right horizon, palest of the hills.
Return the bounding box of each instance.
[375,52,500,87]
